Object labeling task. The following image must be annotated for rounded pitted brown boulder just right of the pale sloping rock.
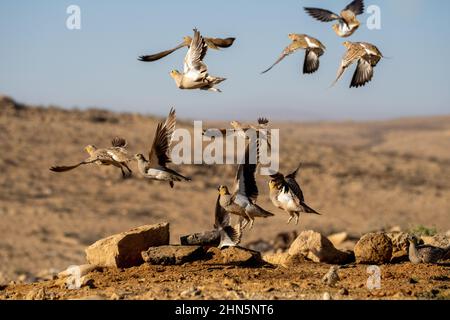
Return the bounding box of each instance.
[355,233,392,264]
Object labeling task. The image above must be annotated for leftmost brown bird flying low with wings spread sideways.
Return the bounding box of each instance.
[50,137,132,178]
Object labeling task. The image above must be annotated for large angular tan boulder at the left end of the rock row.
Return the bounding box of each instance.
[86,223,170,268]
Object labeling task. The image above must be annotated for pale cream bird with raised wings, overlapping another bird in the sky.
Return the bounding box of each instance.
[170,29,226,92]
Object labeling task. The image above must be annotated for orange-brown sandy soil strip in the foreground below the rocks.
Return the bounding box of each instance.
[0,260,450,300]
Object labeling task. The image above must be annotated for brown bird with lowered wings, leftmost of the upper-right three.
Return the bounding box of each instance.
[262,33,326,74]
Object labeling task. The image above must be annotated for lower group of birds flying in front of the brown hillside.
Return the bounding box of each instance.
[50,109,319,247]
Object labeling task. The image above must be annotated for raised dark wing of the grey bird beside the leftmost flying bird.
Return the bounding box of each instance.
[146,108,176,169]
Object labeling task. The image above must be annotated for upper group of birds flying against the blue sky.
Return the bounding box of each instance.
[139,0,383,92]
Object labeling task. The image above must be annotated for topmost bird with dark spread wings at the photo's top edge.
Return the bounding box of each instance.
[304,0,364,38]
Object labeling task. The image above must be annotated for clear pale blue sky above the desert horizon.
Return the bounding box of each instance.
[0,0,450,121]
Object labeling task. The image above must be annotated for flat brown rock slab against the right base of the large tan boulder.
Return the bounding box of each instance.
[142,246,206,265]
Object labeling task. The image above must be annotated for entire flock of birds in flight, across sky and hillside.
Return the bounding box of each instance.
[50,0,383,247]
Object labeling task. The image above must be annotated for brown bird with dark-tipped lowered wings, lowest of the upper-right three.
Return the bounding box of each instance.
[332,41,383,88]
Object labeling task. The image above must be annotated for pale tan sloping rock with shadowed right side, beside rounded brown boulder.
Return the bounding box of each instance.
[288,230,353,264]
